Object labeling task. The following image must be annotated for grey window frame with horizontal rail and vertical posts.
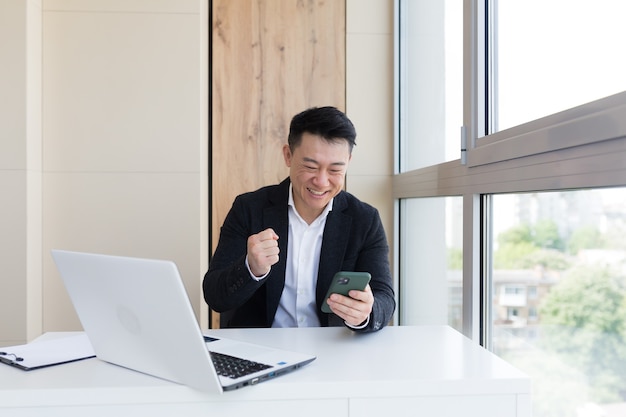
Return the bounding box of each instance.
[392,0,626,347]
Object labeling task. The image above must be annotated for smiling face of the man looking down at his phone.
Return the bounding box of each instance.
[283,132,351,224]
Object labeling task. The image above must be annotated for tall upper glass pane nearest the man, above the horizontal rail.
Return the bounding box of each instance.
[400,0,463,172]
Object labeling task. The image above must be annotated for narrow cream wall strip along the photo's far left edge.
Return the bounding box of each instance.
[0,0,42,344]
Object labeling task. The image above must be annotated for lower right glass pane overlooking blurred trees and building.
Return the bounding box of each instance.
[491,188,626,417]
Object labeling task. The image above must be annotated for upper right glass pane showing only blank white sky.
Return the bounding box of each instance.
[492,0,626,130]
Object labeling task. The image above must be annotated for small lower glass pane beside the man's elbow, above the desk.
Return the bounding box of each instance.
[399,197,463,331]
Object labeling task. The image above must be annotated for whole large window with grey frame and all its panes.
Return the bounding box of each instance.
[393,0,626,417]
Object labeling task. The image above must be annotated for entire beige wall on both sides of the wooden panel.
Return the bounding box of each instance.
[0,0,393,345]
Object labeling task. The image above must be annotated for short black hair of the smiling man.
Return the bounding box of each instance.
[288,106,356,153]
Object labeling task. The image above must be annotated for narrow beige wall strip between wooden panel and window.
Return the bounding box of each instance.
[346,0,394,259]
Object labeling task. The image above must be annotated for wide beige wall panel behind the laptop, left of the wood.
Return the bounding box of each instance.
[43,0,207,331]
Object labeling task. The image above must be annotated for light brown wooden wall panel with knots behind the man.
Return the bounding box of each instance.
[210,0,346,327]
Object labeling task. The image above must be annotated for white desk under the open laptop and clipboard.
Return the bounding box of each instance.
[0,326,531,417]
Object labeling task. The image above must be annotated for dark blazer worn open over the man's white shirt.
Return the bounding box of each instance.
[203,178,395,332]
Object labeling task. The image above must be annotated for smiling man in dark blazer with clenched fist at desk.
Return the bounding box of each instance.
[203,107,395,332]
